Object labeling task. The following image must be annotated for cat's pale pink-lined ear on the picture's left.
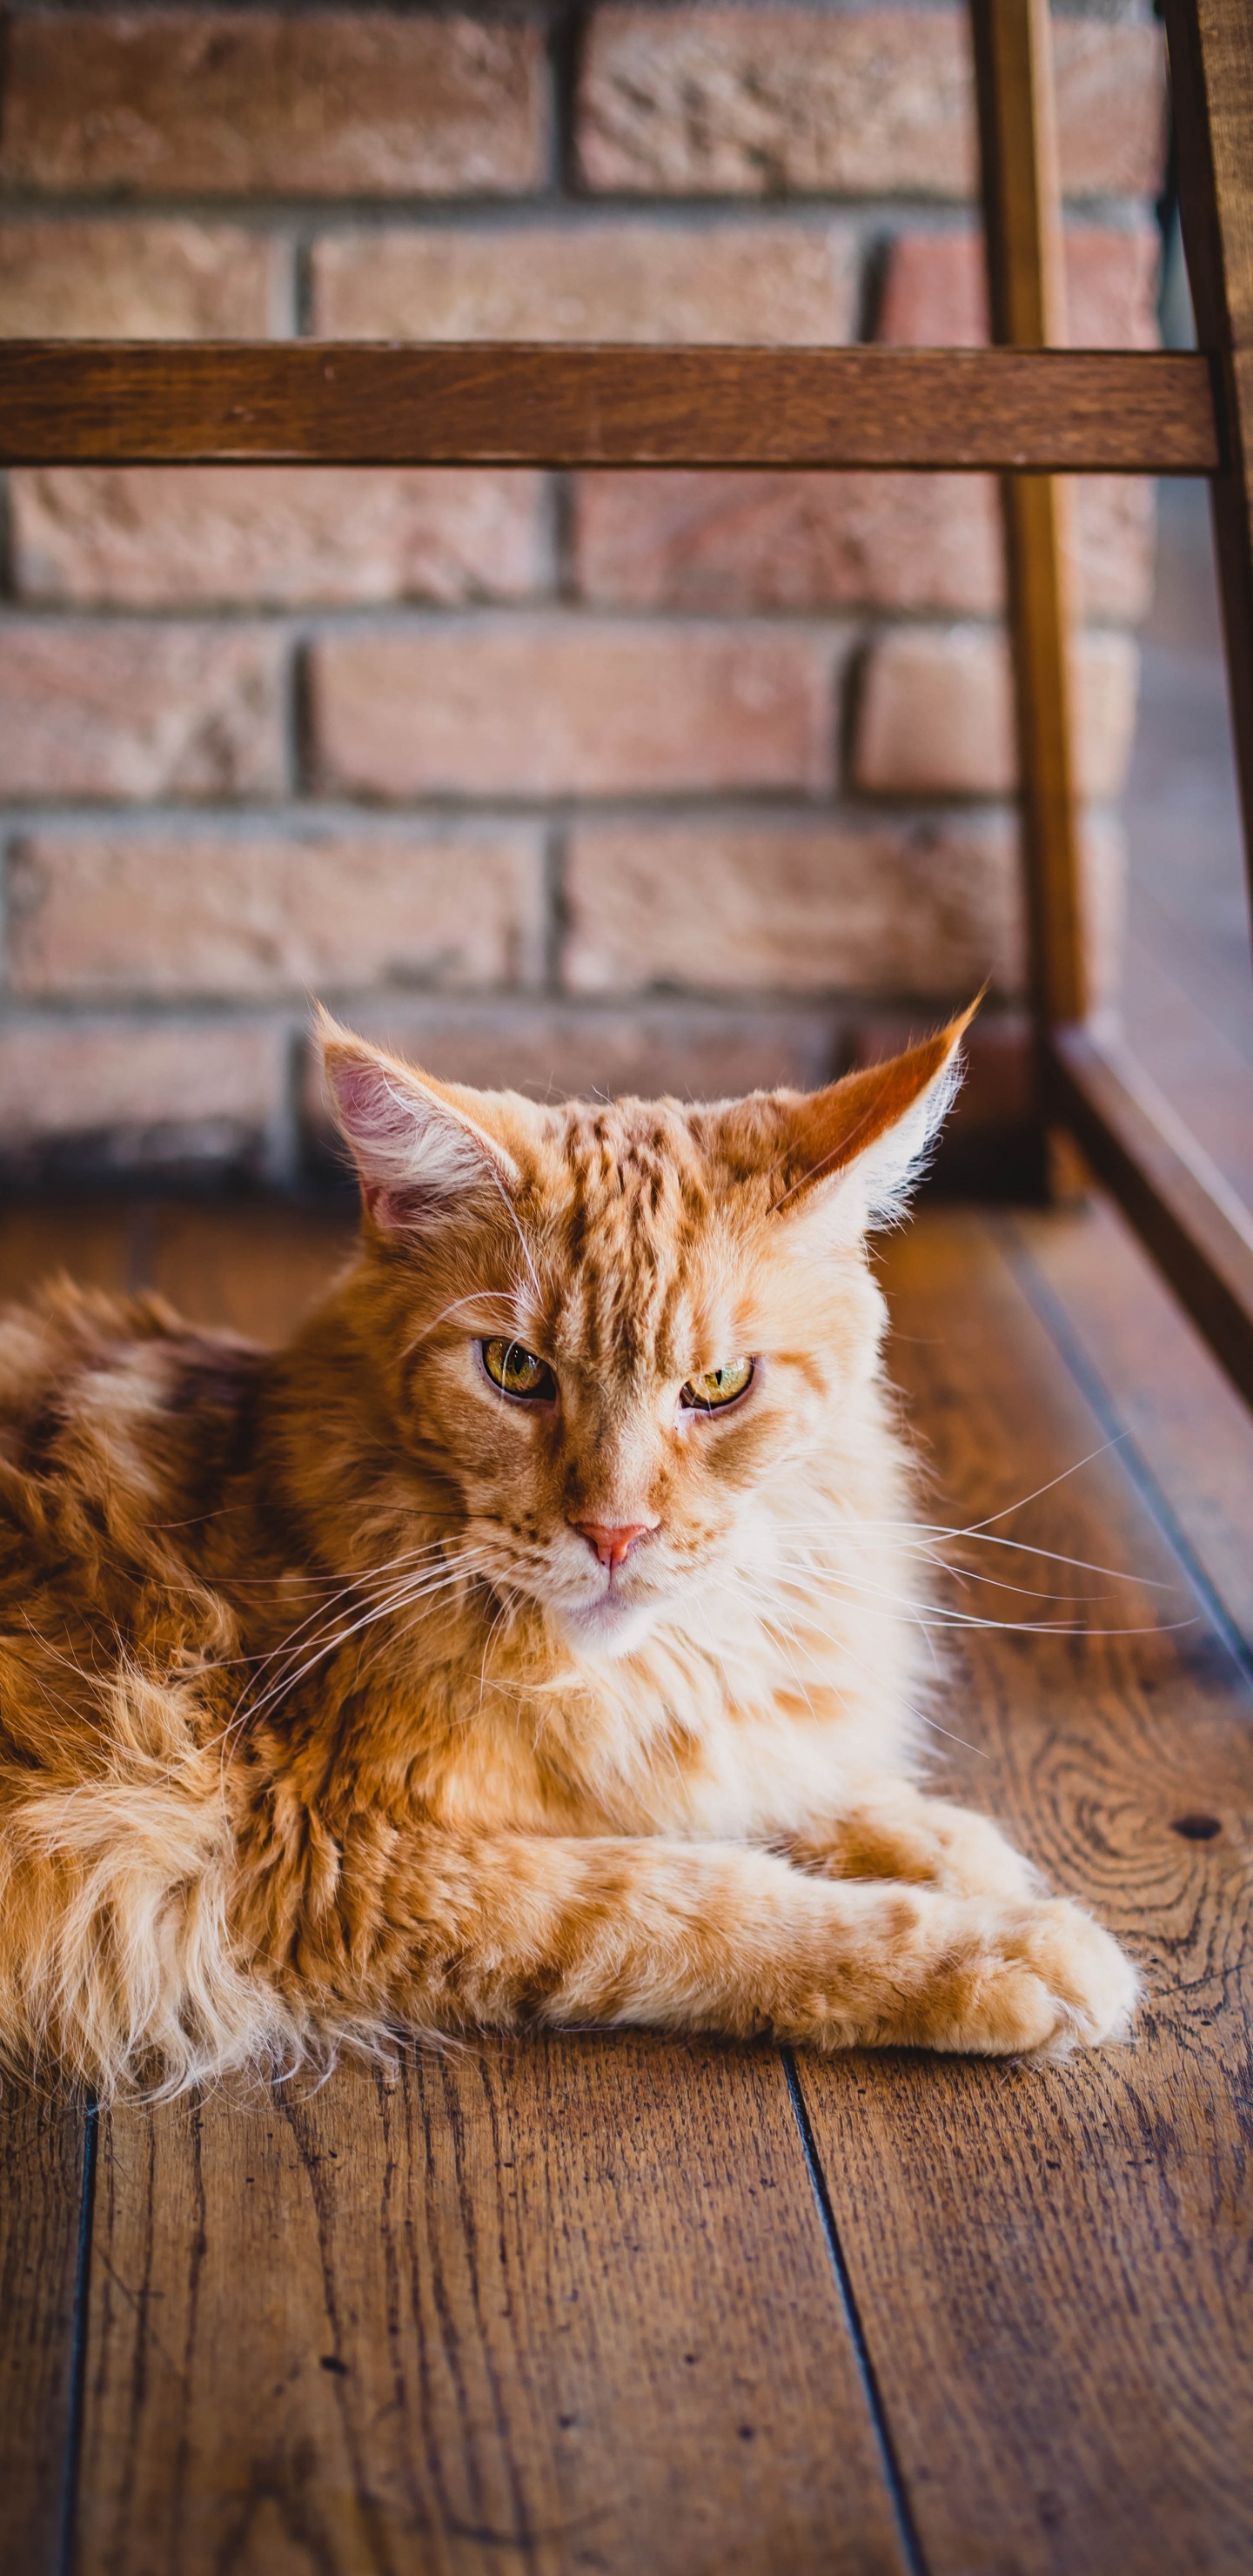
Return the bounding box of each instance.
[317,1012,521,1234]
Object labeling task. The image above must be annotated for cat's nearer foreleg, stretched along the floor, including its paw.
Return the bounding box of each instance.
[340,1836,1137,2056]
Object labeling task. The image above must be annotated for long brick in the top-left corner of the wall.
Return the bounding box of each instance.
[0,8,546,196]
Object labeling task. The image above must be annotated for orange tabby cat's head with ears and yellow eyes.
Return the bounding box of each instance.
[322,1012,969,1654]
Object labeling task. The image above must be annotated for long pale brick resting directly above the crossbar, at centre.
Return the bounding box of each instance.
[314,217,859,345]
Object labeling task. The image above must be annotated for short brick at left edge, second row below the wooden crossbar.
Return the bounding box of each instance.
[0,621,284,796]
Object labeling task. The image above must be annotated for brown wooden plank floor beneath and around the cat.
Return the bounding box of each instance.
[0,1208,1253,2576]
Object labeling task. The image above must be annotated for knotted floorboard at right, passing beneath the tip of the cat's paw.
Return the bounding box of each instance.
[801,1216,1253,2576]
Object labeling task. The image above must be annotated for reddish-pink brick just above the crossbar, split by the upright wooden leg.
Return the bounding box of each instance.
[876,225,1157,348]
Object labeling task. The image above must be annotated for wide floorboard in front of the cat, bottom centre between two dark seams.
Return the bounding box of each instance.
[75,2035,902,2576]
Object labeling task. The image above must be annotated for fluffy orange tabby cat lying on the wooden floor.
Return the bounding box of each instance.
[0,1020,1137,2094]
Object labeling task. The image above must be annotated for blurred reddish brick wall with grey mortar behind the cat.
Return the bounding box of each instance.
[0,0,1163,1180]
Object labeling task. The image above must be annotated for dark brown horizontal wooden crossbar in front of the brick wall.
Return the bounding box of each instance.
[0,340,1222,474]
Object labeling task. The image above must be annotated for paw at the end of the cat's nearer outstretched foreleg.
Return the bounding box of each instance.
[923,1899,1140,2058]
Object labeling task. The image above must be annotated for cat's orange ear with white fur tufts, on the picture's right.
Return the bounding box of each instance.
[753,995,982,1237]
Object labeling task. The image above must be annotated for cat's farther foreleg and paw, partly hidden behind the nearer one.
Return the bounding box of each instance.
[776,1780,1042,1896]
